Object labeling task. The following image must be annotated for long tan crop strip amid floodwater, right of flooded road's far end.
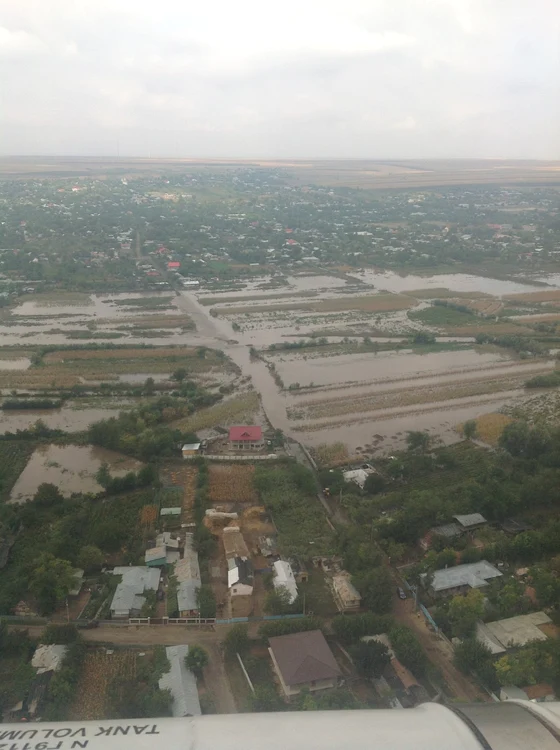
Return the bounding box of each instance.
[212,294,415,315]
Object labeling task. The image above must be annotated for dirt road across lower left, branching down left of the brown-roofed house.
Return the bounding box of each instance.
[18,625,237,714]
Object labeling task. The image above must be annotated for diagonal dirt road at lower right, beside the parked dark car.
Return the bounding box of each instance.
[393,597,490,702]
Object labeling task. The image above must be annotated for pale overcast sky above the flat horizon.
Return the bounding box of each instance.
[0,0,560,159]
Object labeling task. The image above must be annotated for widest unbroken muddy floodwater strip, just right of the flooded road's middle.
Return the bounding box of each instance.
[273,349,511,386]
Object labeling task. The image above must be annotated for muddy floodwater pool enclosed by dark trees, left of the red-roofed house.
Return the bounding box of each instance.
[10,445,142,503]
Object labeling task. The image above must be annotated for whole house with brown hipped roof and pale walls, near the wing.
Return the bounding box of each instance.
[268,630,342,697]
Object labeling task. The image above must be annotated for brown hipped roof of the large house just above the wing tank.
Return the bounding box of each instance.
[269,630,341,685]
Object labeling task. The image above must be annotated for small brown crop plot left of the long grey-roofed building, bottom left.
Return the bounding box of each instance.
[70,649,138,721]
